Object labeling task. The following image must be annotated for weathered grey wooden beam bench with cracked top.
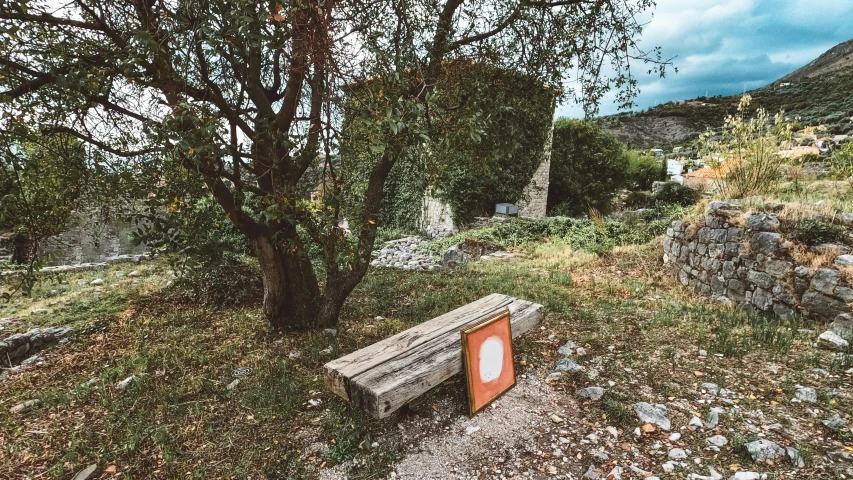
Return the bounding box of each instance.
[324,293,543,418]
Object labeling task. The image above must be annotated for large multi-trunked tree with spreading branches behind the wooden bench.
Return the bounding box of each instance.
[0,0,669,329]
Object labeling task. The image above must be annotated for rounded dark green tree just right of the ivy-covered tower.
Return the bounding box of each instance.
[548,118,629,216]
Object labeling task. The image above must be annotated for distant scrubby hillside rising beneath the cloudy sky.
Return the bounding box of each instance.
[598,40,853,148]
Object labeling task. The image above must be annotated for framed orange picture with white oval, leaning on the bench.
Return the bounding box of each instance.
[462,310,515,415]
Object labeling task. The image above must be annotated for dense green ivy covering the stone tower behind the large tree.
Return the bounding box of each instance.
[342,60,557,230]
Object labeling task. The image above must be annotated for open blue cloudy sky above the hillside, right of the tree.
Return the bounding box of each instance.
[557,0,853,117]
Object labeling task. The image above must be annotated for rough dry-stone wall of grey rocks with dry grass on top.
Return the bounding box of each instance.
[664,202,853,320]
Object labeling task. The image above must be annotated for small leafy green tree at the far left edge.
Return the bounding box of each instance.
[0,135,88,266]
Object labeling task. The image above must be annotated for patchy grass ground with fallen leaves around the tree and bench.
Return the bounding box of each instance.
[0,241,851,479]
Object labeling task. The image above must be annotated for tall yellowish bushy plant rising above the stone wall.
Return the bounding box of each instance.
[700,95,793,198]
